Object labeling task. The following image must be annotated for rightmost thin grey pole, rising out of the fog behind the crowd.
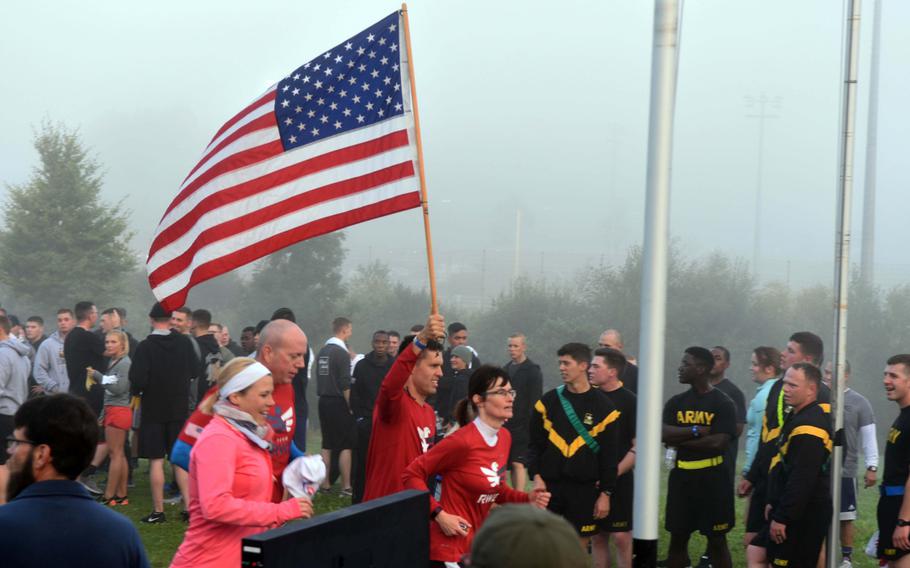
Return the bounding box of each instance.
[859,0,882,285]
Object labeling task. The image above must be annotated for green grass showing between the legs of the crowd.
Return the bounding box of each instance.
[107,435,878,568]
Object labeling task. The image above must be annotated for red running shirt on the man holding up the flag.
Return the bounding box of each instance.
[363,347,436,501]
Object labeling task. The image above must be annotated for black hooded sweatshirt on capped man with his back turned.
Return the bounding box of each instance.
[129,330,198,423]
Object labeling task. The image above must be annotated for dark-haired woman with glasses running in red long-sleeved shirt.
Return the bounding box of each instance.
[403,365,550,566]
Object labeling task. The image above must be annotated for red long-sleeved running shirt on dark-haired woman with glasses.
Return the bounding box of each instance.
[404,422,528,562]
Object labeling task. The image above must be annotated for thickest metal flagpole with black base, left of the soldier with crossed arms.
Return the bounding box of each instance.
[633,0,679,568]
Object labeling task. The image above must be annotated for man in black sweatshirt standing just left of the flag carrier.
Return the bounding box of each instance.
[351,330,392,503]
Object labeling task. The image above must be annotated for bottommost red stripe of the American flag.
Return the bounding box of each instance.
[155,192,420,307]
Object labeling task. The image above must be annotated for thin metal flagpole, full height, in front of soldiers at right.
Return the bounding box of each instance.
[826,0,860,568]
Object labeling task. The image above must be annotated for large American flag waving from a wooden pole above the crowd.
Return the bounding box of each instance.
[146,12,420,309]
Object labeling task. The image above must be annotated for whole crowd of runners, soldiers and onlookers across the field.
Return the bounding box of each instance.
[0,302,910,568]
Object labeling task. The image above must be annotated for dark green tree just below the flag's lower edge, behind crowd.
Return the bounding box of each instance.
[237,233,346,336]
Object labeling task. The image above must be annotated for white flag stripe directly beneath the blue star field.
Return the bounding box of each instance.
[158,117,408,236]
